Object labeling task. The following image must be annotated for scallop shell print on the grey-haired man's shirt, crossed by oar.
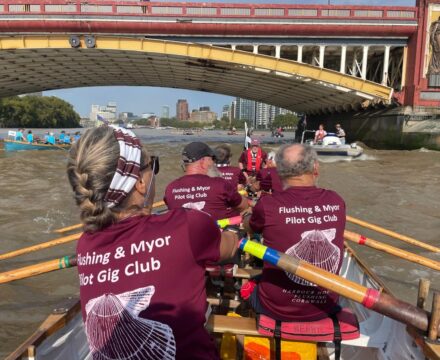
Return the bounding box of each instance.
[286,228,341,286]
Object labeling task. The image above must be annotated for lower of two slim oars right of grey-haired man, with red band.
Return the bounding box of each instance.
[344,230,440,271]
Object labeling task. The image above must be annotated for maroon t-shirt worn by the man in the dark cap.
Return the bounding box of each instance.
[164,174,242,220]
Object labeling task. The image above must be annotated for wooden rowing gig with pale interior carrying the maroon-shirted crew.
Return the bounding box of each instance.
[7,246,440,360]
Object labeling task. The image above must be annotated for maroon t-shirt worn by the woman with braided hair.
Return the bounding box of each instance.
[77,209,220,360]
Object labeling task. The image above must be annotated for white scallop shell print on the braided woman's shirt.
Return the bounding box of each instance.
[85,286,176,360]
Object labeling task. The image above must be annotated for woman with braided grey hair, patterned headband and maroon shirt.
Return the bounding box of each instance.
[67,126,238,360]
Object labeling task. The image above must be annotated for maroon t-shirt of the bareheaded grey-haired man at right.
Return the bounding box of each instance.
[250,186,345,321]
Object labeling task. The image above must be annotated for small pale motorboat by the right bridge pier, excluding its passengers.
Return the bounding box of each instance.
[301,130,364,158]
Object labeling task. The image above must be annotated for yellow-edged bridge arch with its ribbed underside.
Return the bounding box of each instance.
[0,36,392,113]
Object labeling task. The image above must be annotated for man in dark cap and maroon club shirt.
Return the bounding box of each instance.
[164,142,248,220]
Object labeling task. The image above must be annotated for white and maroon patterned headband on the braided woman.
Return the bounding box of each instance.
[104,126,141,208]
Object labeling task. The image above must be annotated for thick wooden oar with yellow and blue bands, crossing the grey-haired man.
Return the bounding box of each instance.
[239,239,440,331]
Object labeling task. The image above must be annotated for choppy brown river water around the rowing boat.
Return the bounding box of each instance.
[0,129,440,358]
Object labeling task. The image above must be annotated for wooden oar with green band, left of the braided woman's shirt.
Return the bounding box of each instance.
[0,255,77,284]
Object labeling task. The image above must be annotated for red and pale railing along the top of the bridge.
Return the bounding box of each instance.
[0,0,418,21]
